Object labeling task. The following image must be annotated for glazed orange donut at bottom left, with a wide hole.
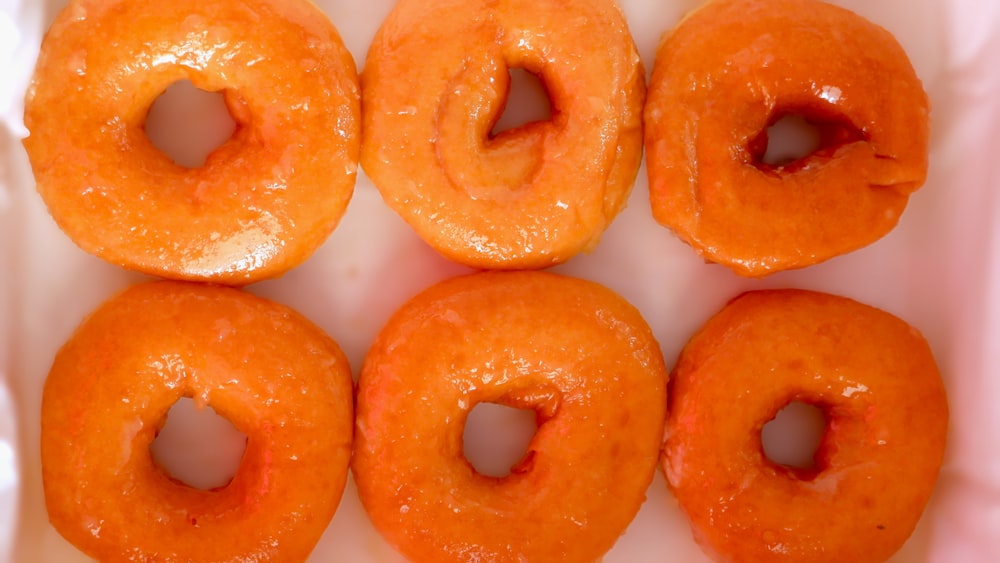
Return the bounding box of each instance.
[41,282,354,561]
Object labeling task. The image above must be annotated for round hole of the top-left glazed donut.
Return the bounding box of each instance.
[145,80,236,168]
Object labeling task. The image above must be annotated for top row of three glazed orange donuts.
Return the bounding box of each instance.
[24,0,928,285]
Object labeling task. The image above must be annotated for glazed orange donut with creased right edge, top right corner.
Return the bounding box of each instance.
[645,0,929,277]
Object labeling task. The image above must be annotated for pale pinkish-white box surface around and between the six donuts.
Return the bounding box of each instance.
[0,0,1000,563]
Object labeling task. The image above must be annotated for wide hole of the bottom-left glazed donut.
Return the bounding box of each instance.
[149,398,247,491]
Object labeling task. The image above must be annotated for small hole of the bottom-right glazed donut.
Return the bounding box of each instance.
[760,401,827,480]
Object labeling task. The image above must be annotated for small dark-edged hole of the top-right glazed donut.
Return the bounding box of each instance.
[750,111,863,170]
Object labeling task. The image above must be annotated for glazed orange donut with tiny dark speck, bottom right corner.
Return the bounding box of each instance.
[663,290,948,563]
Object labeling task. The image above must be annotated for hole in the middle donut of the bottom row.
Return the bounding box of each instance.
[462,403,538,478]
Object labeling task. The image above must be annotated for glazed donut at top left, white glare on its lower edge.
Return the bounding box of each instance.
[24,0,360,284]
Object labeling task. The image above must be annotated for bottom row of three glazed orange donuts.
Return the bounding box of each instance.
[42,271,948,563]
